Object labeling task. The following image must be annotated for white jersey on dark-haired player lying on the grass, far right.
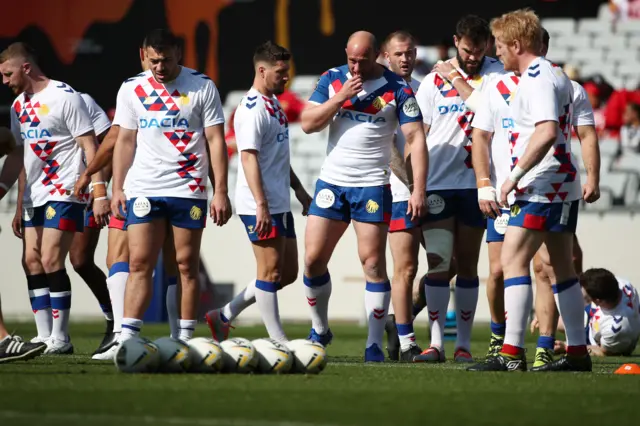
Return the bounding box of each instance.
[589,278,640,354]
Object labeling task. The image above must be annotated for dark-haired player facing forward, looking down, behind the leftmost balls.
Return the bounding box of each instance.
[111,30,231,341]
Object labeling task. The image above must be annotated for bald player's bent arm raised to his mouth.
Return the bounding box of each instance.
[300,73,362,134]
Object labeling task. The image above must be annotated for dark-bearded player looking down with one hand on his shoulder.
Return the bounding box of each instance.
[416,15,503,362]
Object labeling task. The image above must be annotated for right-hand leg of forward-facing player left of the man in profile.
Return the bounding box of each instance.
[173,226,203,342]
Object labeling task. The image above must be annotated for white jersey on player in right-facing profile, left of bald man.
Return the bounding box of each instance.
[233,87,291,215]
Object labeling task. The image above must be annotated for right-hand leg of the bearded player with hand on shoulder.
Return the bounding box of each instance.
[454,221,484,362]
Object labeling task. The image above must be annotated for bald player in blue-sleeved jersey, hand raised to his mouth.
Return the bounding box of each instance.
[302,31,428,362]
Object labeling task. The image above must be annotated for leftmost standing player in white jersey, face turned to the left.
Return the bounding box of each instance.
[0,43,109,354]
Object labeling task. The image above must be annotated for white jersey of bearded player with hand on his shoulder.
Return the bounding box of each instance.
[416,57,504,191]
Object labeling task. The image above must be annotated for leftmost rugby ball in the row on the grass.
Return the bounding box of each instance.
[113,337,160,373]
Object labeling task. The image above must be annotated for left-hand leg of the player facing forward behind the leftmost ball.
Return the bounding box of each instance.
[120,219,167,341]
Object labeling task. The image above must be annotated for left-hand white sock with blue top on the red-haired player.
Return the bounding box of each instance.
[502,275,532,355]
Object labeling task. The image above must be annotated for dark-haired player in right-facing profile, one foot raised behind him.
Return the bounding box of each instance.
[206,41,311,341]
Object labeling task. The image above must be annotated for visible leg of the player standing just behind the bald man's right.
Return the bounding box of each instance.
[387,228,421,361]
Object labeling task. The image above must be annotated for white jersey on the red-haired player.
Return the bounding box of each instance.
[510,57,582,203]
